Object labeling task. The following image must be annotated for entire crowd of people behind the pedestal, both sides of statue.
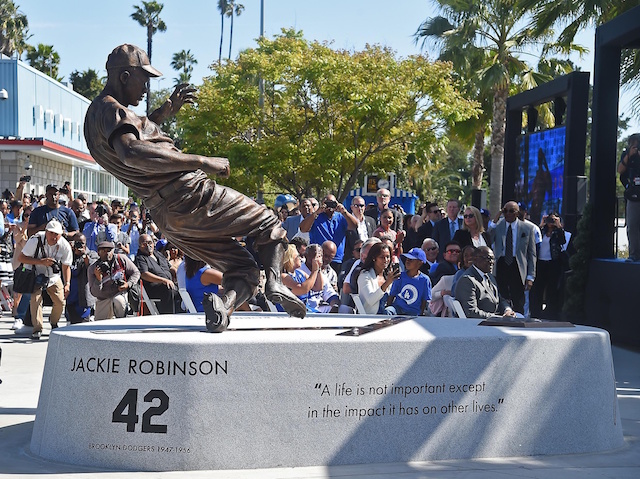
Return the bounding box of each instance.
[0,182,571,339]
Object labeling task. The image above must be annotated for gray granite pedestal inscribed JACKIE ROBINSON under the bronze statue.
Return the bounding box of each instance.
[31,314,623,471]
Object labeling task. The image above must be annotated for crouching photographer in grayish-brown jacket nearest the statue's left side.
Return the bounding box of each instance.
[87,241,140,321]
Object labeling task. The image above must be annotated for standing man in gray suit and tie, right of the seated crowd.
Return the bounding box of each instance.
[492,201,536,314]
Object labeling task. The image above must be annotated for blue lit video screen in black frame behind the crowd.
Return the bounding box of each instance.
[515,126,566,225]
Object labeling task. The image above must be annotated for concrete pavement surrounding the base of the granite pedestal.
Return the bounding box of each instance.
[0,312,640,479]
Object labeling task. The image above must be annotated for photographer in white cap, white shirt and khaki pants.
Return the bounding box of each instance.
[20,219,73,340]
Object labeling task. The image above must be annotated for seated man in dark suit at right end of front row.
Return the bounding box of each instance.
[456,246,516,319]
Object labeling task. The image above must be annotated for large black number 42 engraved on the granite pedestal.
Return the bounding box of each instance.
[111,389,169,434]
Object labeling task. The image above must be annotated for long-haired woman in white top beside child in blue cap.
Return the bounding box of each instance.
[358,243,400,314]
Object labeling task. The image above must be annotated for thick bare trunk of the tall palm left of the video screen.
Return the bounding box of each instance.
[489,87,509,216]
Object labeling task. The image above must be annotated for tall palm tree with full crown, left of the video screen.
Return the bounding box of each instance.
[416,0,548,213]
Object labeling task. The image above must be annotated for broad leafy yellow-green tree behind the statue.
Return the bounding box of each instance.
[179,30,476,199]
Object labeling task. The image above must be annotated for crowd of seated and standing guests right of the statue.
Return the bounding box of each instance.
[274,189,571,320]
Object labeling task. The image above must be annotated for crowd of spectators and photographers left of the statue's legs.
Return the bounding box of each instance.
[0,181,236,340]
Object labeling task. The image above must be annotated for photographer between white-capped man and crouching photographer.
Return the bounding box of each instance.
[65,233,98,324]
